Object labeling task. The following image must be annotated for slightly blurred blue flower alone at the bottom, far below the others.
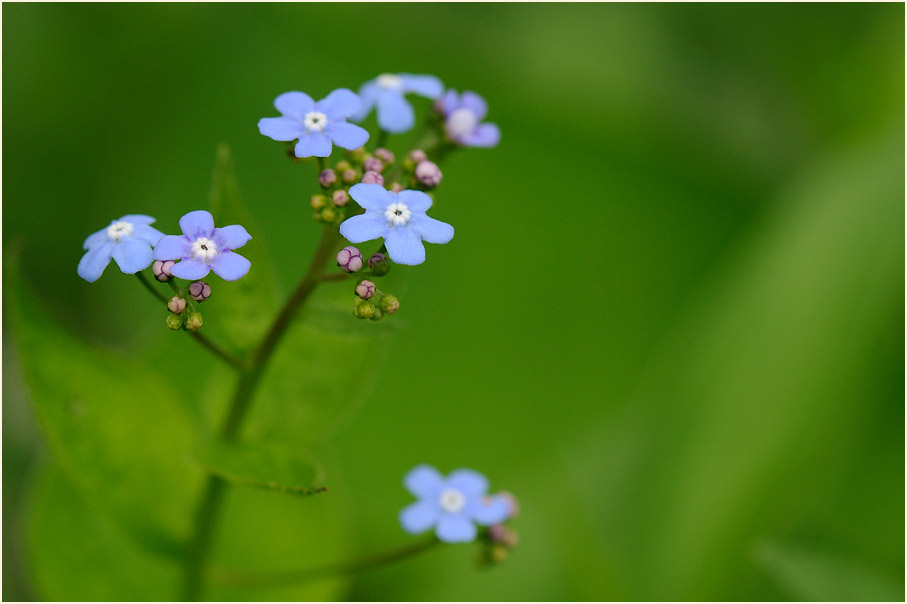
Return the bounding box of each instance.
[400,465,510,543]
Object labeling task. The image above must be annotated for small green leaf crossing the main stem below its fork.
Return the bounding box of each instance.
[196,441,327,496]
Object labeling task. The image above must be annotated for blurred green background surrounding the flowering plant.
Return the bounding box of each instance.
[2,4,905,600]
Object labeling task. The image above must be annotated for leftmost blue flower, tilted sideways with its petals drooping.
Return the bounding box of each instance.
[78,214,164,283]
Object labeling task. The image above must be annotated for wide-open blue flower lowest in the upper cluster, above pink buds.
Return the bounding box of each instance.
[340,183,453,264]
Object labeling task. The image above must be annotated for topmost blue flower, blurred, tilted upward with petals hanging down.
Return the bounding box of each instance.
[353,73,444,134]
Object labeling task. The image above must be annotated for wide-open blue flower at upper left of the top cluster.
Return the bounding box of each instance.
[258,88,368,157]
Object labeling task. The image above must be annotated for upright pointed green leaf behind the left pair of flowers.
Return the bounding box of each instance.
[205,144,280,352]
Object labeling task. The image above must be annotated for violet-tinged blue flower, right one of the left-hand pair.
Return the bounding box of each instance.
[154,210,252,281]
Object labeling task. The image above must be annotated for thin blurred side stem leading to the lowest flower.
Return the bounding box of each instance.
[212,538,440,587]
